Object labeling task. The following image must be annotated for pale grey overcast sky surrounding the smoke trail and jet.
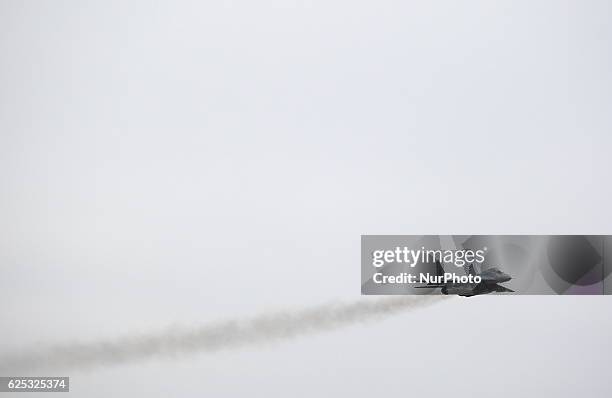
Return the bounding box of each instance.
[0,0,612,397]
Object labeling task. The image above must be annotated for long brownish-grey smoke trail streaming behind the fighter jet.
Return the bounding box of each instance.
[0,296,450,374]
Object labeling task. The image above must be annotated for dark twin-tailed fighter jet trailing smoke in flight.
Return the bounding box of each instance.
[416,261,514,297]
